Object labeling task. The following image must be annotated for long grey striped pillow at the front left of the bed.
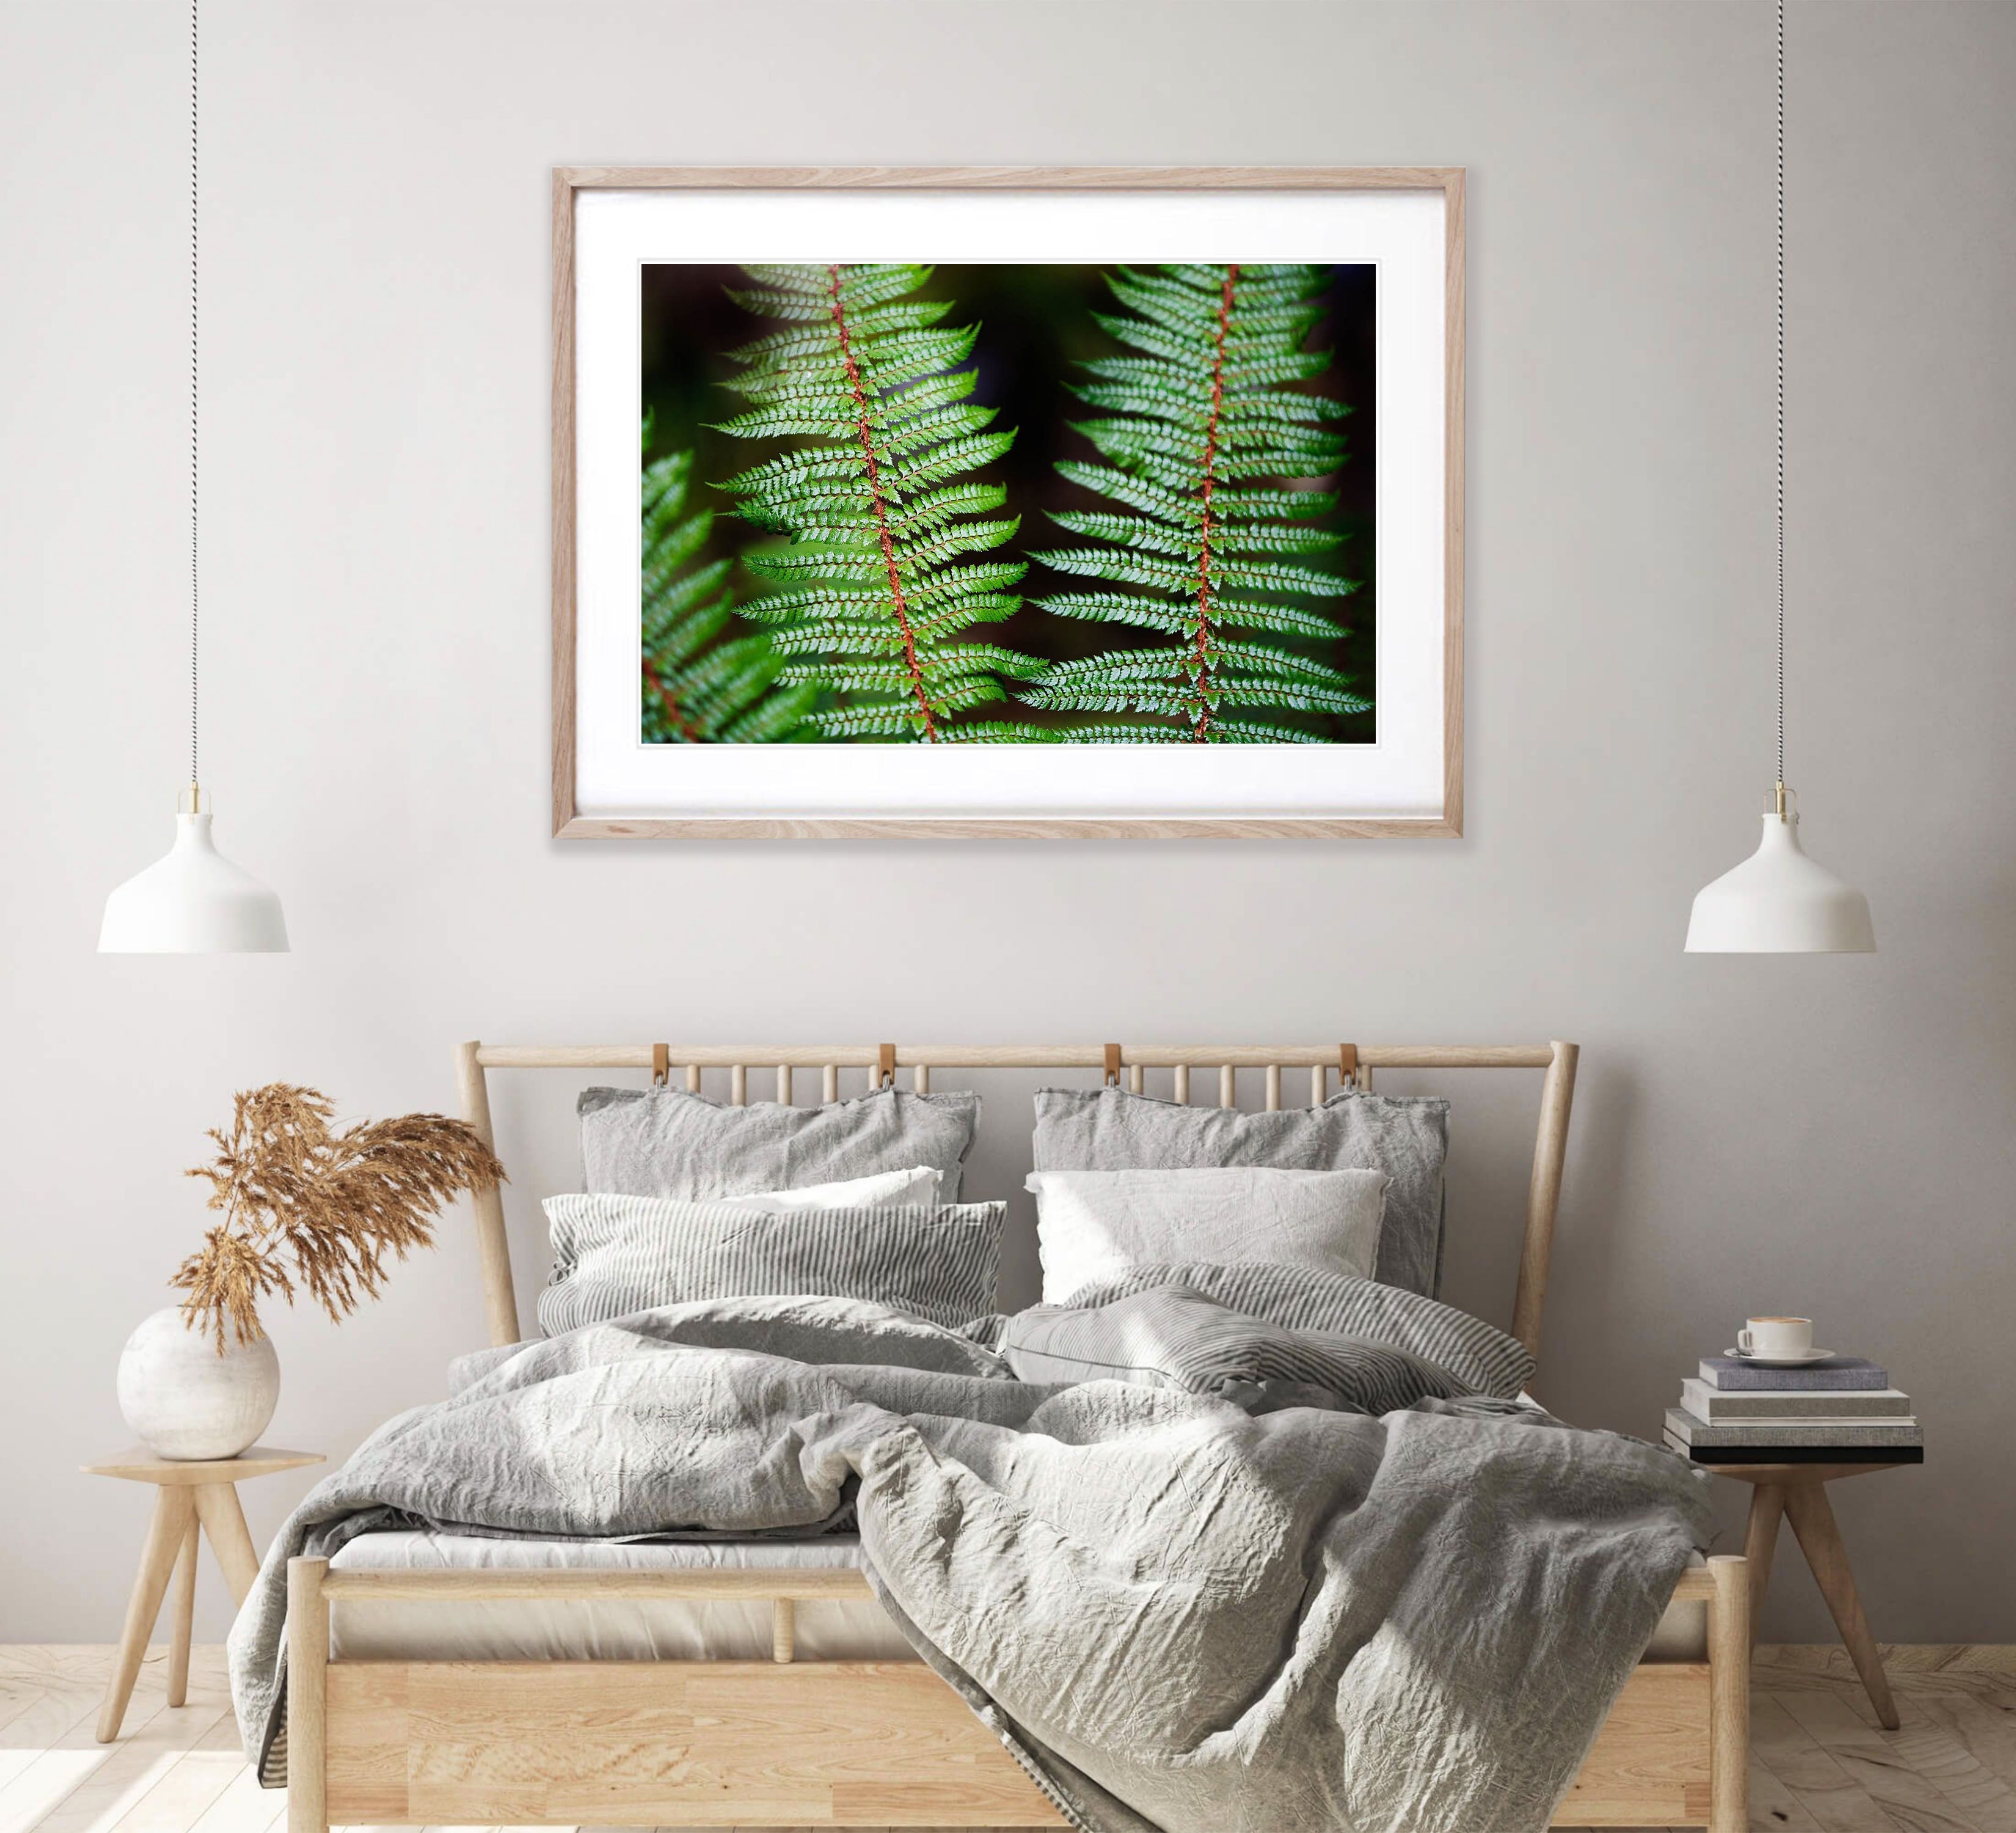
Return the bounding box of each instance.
[538,1196,1006,1337]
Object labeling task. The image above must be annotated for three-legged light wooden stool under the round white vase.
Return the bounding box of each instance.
[85,1444,323,1744]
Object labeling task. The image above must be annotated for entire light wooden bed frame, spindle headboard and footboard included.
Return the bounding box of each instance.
[287,1042,1750,1833]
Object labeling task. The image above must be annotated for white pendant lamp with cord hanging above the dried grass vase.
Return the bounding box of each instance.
[99,0,287,954]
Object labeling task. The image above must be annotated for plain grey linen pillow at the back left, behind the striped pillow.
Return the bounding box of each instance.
[575,1089,980,1204]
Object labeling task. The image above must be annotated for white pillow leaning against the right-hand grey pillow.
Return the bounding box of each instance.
[1028,1166,1387,1304]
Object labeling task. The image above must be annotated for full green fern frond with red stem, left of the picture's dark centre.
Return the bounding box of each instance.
[721,264,1042,740]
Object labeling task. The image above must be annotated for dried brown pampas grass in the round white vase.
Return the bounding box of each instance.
[172,1083,504,1355]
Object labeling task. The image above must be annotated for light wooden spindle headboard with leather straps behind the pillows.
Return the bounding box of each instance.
[456,1042,1577,1359]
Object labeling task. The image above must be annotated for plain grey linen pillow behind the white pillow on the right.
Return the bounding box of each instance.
[1036,1089,1450,1297]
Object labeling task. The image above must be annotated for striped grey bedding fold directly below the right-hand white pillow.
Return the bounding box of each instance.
[1048,1260,1534,1399]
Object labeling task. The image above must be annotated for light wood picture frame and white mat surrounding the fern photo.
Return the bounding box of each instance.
[552,166,1466,839]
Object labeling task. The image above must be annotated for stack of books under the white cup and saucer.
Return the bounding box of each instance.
[1665,1355,1926,1464]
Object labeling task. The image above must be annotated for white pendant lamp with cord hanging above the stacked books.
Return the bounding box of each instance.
[1687,0,1877,954]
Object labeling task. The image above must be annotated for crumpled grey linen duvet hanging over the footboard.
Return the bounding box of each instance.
[230,1298,1706,1833]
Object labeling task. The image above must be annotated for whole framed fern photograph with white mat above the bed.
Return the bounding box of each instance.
[552,167,1464,839]
